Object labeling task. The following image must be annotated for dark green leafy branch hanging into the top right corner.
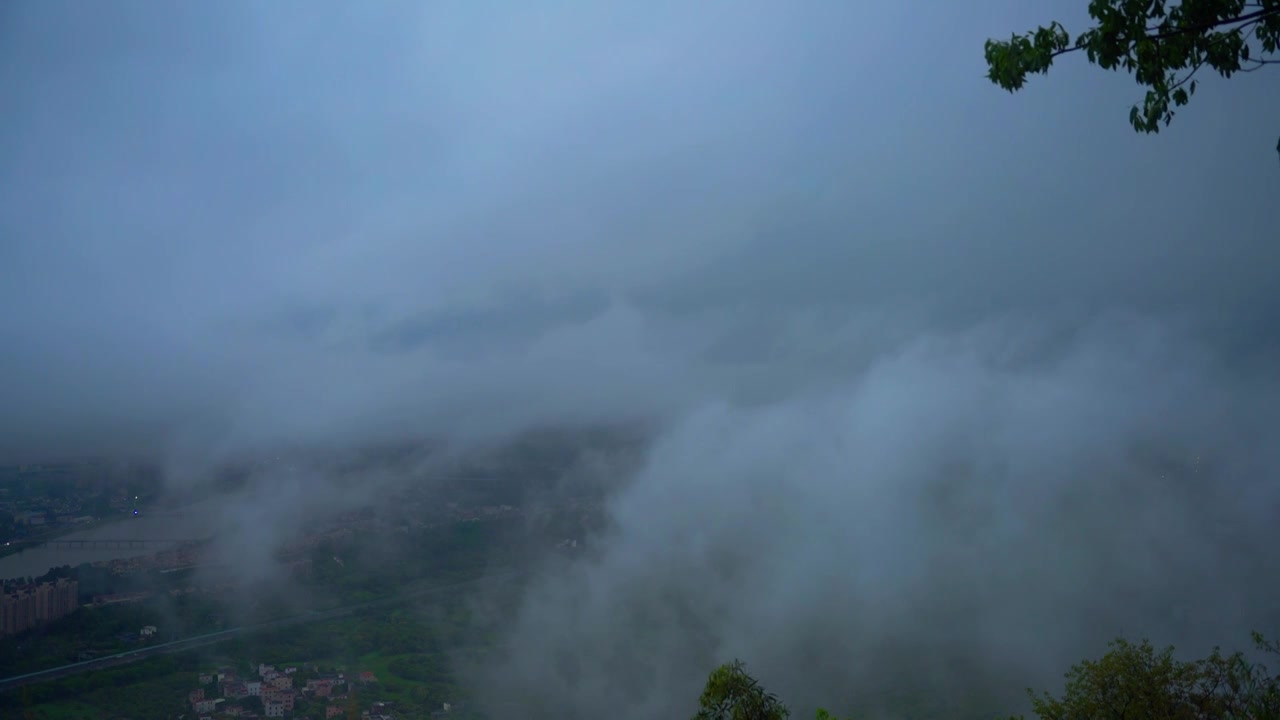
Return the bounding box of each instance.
[986,0,1280,152]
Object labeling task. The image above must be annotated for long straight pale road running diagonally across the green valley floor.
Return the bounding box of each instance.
[0,570,527,692]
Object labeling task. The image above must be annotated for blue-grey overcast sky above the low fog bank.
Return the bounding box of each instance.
[0,1,1280,457]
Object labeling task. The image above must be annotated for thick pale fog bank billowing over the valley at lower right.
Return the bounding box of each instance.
[476,316,1280,719]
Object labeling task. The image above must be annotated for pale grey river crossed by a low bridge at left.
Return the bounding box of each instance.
[0,506,220,578]
